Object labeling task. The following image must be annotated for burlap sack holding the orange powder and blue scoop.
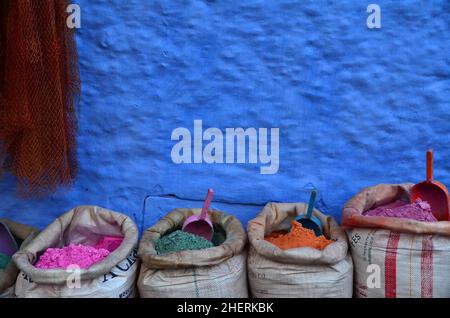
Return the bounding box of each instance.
[247,203,353,298]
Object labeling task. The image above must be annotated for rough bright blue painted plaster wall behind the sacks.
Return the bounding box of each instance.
[0,0,450,232]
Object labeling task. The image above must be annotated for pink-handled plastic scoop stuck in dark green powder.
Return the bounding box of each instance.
[183,189,214,241]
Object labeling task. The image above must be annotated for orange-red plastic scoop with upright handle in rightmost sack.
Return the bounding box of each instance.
[411,149,450,221]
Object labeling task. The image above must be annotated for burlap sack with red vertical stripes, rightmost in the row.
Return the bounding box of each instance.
[342,183,450,298]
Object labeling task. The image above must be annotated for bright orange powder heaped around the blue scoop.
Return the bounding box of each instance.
[265,221,333,250]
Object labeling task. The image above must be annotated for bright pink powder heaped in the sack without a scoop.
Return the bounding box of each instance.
[35,244,110,269]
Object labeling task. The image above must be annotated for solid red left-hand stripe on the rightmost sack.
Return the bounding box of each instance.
[384,232,400,298]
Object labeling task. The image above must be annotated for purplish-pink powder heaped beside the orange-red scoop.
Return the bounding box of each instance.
[364,200,437,222]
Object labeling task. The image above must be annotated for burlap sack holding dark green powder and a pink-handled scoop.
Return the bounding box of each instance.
[138,209,248,298]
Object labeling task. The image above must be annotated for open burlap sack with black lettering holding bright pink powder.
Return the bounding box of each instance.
[13,206,138,298]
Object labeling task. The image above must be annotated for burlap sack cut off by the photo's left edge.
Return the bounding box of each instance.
[0,218,39,298]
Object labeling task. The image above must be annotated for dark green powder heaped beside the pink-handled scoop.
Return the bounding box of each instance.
[155,230,214,255]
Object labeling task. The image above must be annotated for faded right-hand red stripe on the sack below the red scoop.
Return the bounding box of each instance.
[420,235,433,298]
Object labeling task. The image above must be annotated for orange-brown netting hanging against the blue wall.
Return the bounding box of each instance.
[0,0,80,196]
